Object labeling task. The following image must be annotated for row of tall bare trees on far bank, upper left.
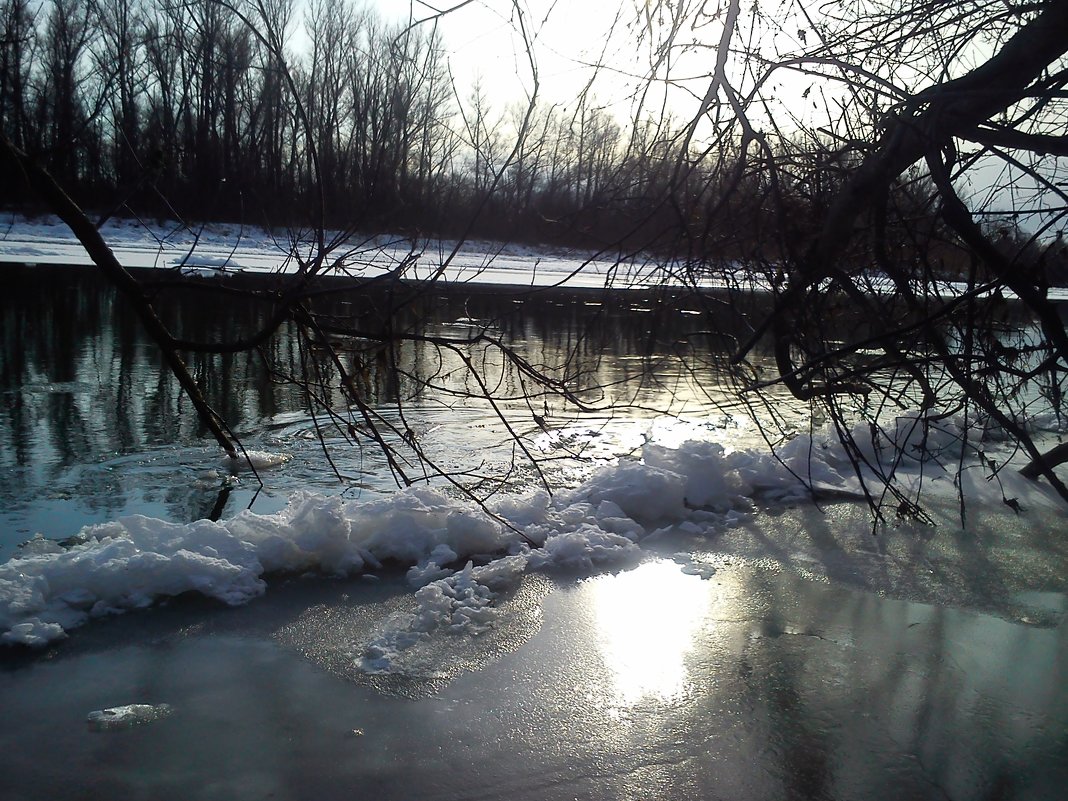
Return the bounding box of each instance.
[0,0,756,247]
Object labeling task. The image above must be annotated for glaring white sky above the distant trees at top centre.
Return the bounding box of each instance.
[354,0,812,130]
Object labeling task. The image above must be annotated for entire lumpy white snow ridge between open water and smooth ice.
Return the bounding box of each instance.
[0,418,1055,649]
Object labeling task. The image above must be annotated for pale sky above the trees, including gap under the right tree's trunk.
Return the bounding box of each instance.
[279,0,1059,227]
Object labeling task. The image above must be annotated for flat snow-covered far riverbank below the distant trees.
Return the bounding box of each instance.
[0,215,1068,303]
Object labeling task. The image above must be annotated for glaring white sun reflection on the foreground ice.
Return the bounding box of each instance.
[591,561,710,706]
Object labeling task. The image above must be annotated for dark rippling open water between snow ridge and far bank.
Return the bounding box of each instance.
[0,267,804,555]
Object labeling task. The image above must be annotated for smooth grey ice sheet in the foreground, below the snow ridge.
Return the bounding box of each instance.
[0,534,1068,801]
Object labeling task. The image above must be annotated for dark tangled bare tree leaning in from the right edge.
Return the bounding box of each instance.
[623,0,1068,514]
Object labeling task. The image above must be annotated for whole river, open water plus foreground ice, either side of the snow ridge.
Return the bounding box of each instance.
[0,261,1068,801]
